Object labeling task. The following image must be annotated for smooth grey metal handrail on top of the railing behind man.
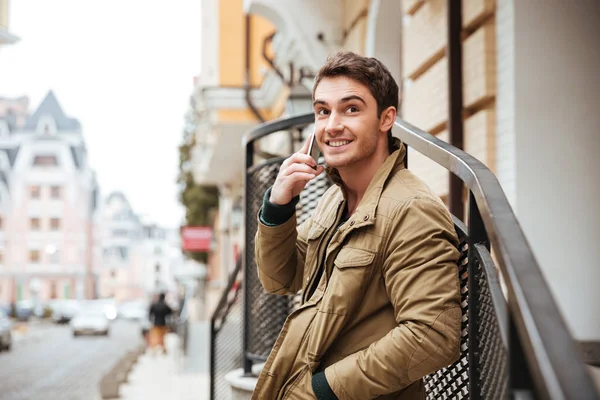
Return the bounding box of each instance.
[243,113,599,399]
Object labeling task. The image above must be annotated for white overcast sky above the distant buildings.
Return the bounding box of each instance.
[0,0,201,227]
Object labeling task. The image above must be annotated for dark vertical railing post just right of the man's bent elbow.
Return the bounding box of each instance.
[468,191,490,400]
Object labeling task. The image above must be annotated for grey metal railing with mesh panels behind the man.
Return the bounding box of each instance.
[233,113,600,399]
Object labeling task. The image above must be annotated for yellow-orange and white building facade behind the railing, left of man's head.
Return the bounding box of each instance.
[185,0,289,304]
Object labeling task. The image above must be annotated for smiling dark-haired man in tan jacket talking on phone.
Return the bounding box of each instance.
[253,52,461,400]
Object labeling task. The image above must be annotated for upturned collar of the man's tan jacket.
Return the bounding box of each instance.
[326,137,406,227]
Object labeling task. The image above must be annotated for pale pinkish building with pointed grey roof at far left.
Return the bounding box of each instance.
[0,92,98,302]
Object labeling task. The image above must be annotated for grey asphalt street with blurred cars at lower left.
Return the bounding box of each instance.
[0,321,142,400]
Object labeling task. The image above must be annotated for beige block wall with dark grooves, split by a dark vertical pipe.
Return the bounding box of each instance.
[401,0,501,197]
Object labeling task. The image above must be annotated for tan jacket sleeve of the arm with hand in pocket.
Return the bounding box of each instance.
[325,198,461,400]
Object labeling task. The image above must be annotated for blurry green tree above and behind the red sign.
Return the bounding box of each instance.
[177,130,219,263]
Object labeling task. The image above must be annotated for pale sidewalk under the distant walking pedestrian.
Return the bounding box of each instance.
[120,328,210,400]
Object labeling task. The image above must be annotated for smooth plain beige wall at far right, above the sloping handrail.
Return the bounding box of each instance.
[512,0,600,341]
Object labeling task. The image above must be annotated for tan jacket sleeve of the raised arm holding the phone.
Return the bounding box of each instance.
[255,214,312,294]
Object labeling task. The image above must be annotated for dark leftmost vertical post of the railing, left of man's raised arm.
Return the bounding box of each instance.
[242,141,254,376]
